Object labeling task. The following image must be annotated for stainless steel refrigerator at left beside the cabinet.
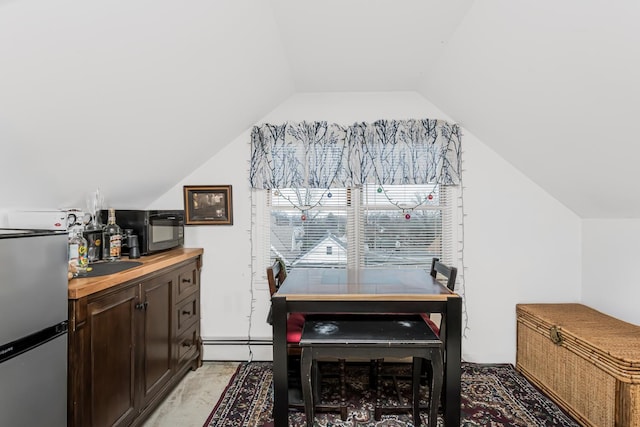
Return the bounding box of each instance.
[0,229,68,427]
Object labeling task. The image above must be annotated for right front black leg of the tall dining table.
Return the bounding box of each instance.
[444,298,462,427]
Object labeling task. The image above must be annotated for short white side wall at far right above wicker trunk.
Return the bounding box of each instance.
[582,219,640,325]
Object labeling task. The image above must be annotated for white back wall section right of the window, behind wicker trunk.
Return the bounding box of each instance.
[462,125,581,363]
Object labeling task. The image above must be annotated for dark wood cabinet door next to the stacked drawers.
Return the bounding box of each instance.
[141,273,177,408]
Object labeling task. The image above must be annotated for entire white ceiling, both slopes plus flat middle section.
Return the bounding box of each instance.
[0,0,640,218]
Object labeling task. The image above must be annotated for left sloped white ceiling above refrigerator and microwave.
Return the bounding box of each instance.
[0,0,293,208]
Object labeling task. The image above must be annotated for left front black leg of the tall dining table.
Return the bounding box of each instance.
[271,295,289,427]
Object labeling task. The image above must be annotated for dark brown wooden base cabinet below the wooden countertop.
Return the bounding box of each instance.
[68,251,202,427]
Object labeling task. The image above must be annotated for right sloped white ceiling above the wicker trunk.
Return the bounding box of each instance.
[421,0,640,218]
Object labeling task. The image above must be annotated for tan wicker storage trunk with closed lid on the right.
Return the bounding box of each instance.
[516,304,640,427]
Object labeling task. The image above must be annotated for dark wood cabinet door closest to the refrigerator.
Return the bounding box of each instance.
[84,285,139,427]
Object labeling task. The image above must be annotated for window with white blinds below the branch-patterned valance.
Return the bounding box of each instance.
[264,184,455,268]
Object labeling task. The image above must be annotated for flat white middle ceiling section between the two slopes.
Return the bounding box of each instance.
[271,0,472,92]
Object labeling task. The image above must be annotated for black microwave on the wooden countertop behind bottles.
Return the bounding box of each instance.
[100,209,184,255]
